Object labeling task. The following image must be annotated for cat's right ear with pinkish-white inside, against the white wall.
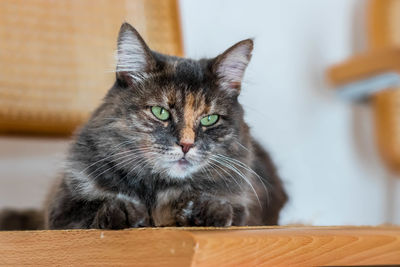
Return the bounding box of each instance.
[212,39,253,95]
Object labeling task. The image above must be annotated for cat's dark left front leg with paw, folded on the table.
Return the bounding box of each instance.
[46,183,150,229]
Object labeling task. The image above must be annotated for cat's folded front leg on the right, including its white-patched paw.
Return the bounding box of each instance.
[173,194,246,227]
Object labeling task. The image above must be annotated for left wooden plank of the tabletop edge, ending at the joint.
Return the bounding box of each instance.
[0,229,194,266]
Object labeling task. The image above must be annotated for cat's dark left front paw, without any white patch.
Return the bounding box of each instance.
[92,199,150,229]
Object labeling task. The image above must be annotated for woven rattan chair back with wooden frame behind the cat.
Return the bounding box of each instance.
[0,0,182,135]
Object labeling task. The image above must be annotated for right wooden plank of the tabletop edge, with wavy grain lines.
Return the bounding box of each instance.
[190,227,400,266]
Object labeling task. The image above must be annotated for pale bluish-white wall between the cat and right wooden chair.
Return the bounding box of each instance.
[180,0,400,225]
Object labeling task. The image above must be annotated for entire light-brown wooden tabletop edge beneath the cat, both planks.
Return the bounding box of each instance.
[0,227,400,266]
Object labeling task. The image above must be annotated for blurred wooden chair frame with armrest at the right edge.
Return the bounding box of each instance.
[328,0,400,173]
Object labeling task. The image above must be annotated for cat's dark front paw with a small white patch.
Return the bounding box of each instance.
[176,196,234,227]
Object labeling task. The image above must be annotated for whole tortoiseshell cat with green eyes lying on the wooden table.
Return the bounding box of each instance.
[39,23,287,229]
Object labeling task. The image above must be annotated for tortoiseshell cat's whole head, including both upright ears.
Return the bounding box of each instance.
[91,24,252,179]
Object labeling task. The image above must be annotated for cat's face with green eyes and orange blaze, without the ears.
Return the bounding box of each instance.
[115,70,242,178]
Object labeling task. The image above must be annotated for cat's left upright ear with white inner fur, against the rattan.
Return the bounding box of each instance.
[116,23,156,84]
